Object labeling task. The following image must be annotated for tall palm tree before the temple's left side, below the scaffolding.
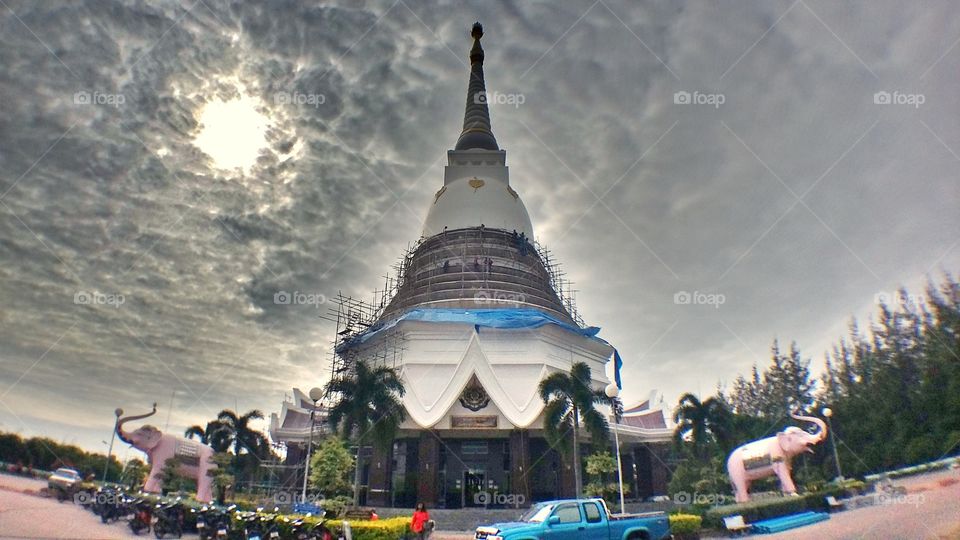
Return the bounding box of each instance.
[325,362,406,505]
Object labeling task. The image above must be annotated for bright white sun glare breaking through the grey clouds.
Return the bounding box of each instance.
[193,90,270,170]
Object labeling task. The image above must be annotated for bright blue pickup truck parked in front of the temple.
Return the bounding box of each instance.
[475,499,670,540]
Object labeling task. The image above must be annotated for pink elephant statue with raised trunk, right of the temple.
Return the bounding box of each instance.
[727,414,827,502]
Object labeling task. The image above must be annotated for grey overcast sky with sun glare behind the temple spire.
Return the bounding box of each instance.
[0,0,960,456]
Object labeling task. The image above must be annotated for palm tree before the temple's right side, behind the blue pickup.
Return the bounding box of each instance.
[539,362,610,498]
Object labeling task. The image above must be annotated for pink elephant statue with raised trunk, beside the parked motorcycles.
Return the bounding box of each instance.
[117,403,217,502]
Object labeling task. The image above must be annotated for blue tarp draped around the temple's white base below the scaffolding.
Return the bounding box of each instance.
[337,308,623,388]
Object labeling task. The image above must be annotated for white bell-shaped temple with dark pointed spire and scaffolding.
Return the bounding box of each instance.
[270,23,672,508]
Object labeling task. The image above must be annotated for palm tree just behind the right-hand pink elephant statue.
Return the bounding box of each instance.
[673,393,731,458]
